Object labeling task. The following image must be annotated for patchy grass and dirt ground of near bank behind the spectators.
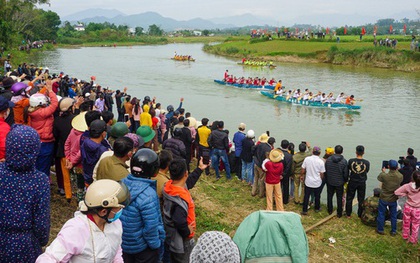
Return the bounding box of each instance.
[50,170,420,262]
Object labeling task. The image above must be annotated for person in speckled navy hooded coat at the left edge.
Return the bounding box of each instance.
[0,125,50,262]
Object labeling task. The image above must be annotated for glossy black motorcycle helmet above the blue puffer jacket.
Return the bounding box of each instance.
[130,148,159,178]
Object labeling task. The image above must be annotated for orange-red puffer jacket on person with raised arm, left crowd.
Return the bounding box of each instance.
[29,92,58,142]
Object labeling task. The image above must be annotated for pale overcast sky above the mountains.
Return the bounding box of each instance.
[41,0,420,22]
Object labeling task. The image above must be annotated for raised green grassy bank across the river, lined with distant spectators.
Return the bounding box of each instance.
[203,37,420,72]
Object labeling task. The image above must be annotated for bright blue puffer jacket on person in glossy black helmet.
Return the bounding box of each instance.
[120,174,165,254]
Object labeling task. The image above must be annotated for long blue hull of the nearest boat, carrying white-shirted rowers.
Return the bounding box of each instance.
[260,90,362,110]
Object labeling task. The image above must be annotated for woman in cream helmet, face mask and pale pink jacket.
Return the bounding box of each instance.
[36,179,130,263]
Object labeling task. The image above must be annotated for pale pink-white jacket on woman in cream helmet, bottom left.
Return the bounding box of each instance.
[36,212,123,263]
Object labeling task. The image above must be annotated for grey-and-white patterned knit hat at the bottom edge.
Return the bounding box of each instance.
[190,231,241,263]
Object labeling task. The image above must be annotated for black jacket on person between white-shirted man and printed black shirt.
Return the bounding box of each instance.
[325,154,349,186]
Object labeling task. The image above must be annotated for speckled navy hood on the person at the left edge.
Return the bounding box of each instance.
[6,124,41,172]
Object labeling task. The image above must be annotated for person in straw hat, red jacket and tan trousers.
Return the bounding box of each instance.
[262,149,284,211]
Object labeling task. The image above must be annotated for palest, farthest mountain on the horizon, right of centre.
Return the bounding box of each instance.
[209,14,278,27]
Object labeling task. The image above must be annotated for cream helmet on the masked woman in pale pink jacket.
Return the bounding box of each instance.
[79,179,130,211]
